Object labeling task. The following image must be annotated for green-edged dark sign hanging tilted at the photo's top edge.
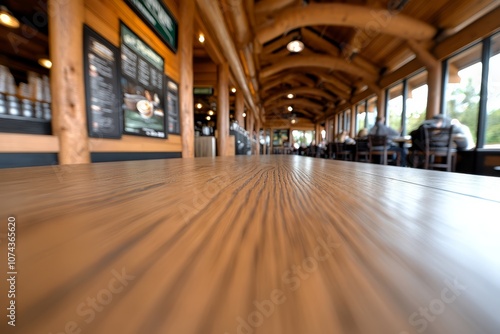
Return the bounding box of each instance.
[125,0,177,52]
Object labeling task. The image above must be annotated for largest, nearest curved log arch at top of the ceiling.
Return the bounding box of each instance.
[256,3,437,44]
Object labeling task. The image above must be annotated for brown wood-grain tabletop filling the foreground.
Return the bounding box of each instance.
[0,156,500,334]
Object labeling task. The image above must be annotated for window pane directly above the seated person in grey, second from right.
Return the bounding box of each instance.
[446,44,482,148]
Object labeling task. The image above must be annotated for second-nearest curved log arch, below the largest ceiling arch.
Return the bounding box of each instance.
[260,55,377,83]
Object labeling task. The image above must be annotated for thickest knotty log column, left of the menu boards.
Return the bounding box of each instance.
[49,0,90,165]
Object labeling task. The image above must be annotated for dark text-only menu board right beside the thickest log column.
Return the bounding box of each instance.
[84,26,122,138]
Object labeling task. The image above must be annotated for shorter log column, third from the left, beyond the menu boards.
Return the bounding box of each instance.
[217,63,229,157]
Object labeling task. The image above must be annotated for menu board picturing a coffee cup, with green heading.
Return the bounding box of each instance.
[120,23,167,138]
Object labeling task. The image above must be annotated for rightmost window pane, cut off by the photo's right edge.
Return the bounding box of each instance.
[484,33,500,149]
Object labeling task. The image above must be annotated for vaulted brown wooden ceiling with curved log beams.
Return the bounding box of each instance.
[195,0,500,124]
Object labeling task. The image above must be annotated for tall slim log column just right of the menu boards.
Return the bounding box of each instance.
[179,0,195,158]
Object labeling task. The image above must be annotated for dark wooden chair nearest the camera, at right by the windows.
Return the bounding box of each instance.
[424,126,457,172]
